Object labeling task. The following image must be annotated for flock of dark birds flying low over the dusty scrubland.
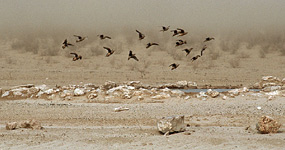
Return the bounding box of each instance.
[62,26,215,70]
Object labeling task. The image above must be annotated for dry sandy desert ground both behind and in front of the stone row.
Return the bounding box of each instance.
[0,32,285,150]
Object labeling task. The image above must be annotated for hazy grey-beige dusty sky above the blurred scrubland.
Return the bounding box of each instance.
[0,0,285,35]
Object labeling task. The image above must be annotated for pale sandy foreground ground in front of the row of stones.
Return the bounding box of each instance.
[0,96,285,150]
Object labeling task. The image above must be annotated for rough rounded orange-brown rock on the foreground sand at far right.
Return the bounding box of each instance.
[256,116,281,134]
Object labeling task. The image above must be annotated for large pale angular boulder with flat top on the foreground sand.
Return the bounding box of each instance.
[157,116,186,135]
